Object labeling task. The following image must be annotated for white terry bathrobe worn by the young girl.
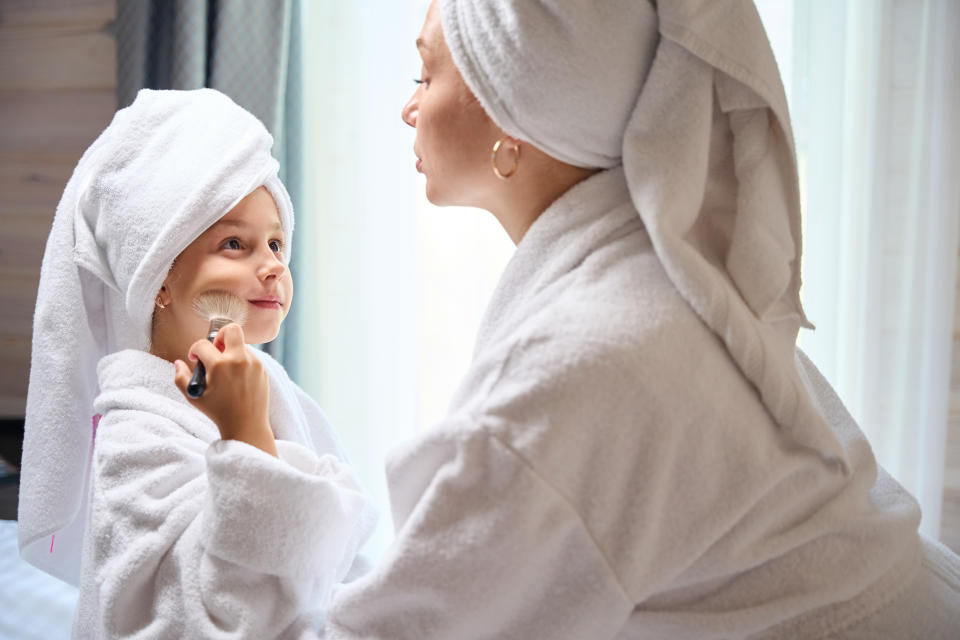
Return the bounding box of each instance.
[74,349,375,639]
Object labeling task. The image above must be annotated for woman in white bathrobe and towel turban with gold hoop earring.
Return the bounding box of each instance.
[318,0,960,639]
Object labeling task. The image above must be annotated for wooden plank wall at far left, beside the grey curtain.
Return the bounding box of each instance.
[0,0,116,417]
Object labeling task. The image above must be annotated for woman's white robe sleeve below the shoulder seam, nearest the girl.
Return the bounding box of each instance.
[326,420,633,640]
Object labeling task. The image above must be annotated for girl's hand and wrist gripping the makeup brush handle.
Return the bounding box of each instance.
[173,324,277,456]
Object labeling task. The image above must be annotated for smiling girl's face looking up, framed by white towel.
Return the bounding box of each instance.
[154,187,293,350]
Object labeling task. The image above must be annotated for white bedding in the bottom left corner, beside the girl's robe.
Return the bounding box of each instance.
[0,520,77,640]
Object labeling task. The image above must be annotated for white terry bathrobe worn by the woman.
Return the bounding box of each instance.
[327,168,960,640]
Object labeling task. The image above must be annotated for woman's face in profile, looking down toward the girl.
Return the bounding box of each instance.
[401,2,499,206]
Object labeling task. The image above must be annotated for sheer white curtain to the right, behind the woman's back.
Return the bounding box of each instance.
[757,0,960,537]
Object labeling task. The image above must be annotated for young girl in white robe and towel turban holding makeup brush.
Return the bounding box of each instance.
[19,89,373,638]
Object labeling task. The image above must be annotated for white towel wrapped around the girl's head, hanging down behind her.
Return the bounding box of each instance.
[18,89,293,584]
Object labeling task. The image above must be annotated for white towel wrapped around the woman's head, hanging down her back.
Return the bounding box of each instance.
[439,0,848,473]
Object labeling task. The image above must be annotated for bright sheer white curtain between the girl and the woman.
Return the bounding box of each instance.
[294,0,512,555]
